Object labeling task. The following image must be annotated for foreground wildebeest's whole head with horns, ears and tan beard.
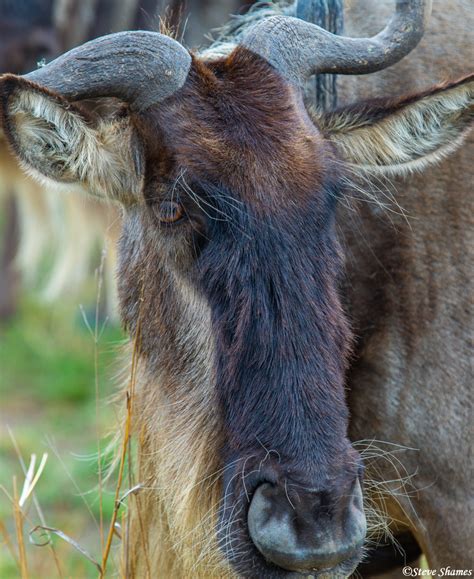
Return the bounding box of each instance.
[1,1,473,577]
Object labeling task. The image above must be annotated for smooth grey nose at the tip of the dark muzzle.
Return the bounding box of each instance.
[248,483,366,572]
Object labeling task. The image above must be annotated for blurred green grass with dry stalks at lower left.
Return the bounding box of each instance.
[0,300,124,579]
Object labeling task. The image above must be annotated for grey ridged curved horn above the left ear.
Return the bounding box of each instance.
[25,31,191,112]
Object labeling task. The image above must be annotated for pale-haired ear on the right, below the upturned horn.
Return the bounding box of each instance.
[316,75,474,175]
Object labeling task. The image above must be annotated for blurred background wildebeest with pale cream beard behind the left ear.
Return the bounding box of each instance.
[0,0,244,319]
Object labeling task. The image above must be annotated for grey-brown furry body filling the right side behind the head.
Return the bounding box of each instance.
[339,0,474,569]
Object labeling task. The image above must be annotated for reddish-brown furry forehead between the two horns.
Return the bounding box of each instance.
[143,47,332,213]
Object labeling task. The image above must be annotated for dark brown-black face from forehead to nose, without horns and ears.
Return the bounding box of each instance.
[118,49,365,577]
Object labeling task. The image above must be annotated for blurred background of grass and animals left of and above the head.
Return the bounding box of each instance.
[0,0,252,579]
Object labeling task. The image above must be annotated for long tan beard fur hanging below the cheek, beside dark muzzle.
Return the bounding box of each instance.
[129,278,227,578]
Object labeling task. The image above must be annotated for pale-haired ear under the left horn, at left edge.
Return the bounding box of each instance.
[0,75,143,205]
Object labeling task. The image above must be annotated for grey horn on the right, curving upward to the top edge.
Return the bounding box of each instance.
[242,0,431,84]
